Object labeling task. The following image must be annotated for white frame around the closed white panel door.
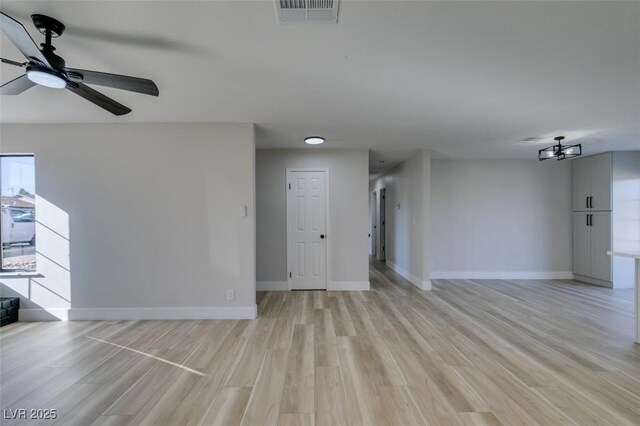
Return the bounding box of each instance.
[284,167,333,291]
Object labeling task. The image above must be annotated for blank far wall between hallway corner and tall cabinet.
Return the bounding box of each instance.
[431,160,572,278]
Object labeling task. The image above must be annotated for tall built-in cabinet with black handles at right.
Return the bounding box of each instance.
[572,151,640,288]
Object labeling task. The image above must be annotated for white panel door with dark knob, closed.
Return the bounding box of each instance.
[287,171,327,290]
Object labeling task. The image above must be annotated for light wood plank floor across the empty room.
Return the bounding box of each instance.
[0,262,640,425]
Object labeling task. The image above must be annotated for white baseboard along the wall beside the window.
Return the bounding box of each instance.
[18,305,258,321]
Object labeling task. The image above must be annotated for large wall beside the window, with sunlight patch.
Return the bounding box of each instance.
[0,124,255,319]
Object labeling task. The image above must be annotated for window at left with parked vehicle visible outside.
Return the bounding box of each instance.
[0,155,36,272]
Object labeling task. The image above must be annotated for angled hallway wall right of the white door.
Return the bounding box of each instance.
[369,151,431,289]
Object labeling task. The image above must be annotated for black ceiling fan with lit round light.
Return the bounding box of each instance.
[0,12,159,115]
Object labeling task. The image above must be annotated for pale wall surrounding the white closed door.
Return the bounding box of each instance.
[256,149,369,285]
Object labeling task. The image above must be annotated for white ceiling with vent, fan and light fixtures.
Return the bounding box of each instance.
[0,0,640,161]
